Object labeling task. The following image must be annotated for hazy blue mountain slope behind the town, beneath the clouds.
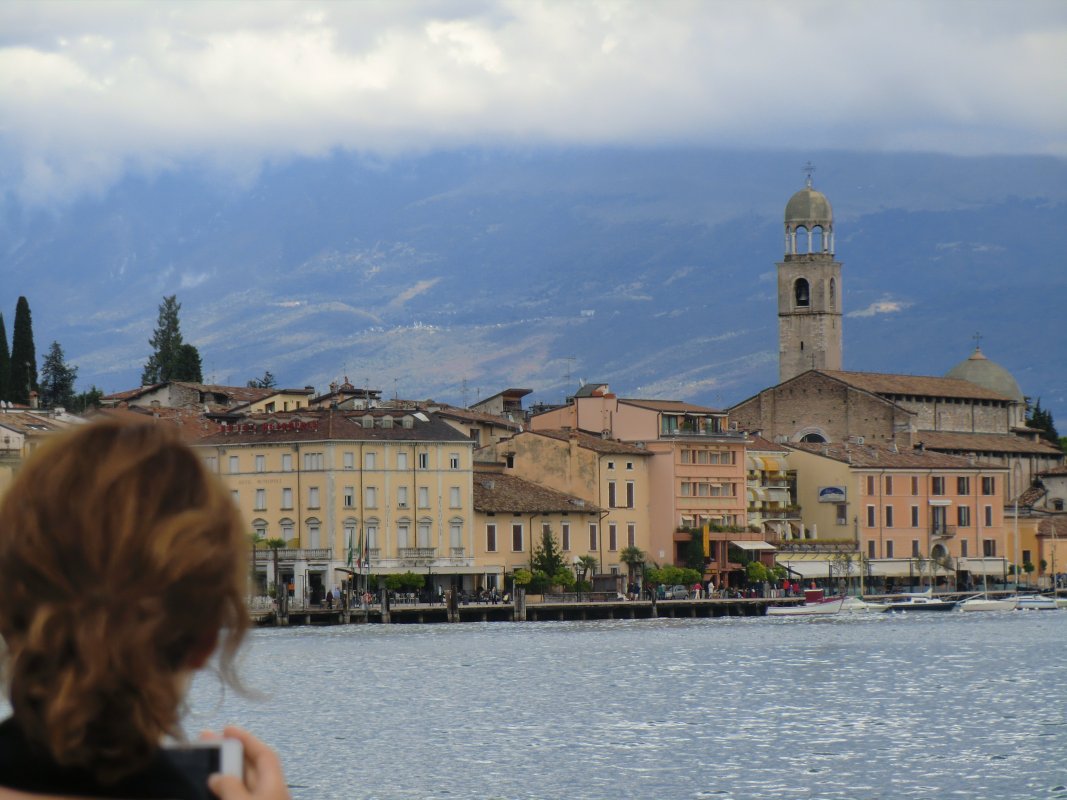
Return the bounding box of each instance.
[0,148,1067,420]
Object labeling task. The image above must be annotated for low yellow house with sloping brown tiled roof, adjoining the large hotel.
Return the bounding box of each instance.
[474,463,603,590]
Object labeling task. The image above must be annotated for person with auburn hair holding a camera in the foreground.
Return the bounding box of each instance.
[0,421,289,800]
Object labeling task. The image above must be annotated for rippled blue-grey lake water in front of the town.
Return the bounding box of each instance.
[183,611,1067,800]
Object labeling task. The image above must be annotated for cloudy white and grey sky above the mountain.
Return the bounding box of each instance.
[0,0,1067,207]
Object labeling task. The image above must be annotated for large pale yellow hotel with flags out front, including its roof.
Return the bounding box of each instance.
[194,409,479,602]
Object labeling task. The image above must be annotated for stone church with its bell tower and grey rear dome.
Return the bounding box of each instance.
[729,172,1064,503]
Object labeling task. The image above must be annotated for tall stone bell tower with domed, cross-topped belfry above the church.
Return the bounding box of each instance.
[778,164,841,382]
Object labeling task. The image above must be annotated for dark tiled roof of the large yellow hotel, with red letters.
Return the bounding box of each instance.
[198,409,472,445]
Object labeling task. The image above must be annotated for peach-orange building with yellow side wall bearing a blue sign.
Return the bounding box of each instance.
[778,444,1016,586]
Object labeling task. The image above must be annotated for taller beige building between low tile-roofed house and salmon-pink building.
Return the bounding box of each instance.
[475,430,652,574]
